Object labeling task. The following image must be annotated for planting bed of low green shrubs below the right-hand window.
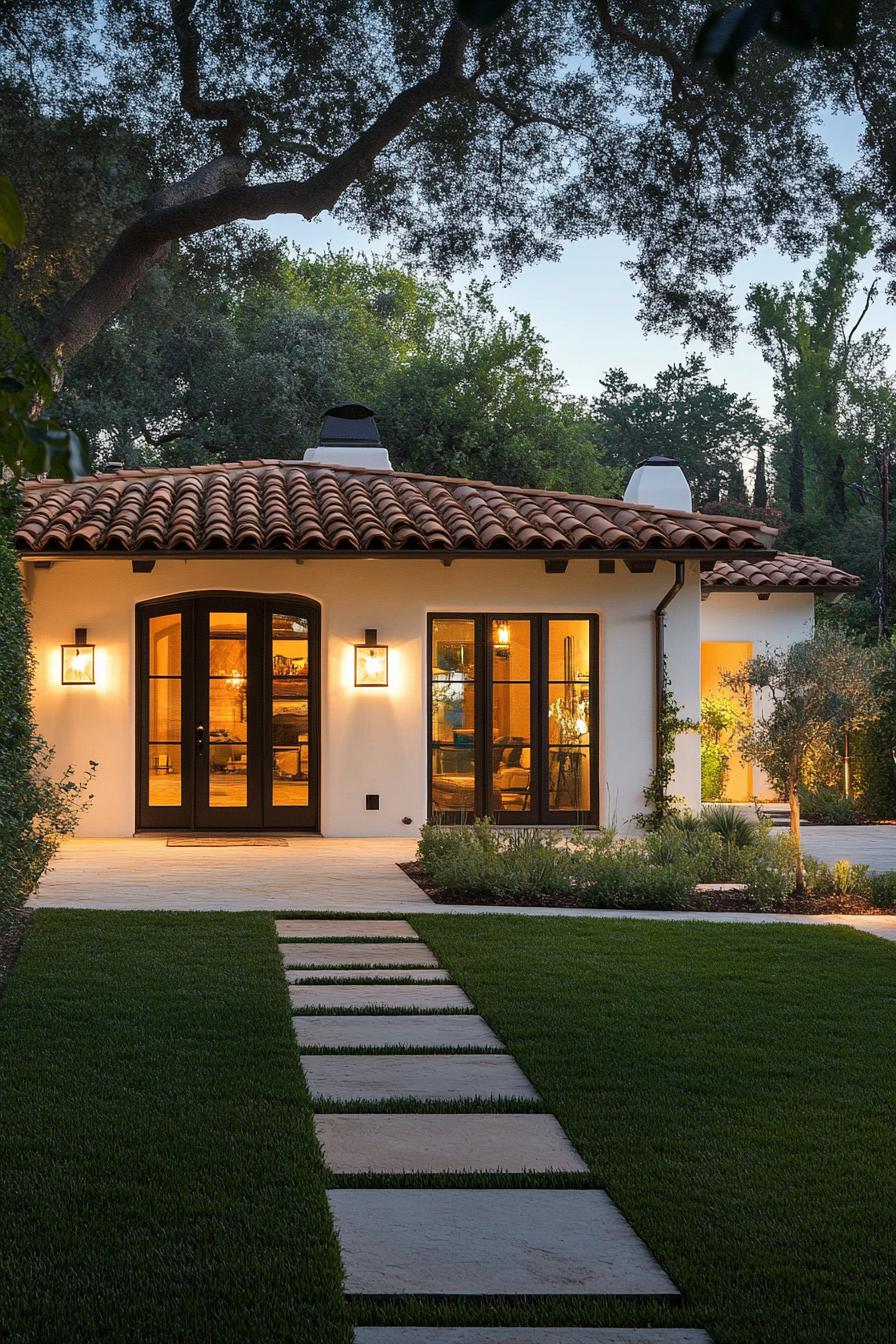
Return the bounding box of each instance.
[411,806,896,914]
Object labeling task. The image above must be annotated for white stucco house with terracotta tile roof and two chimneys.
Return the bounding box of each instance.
[16,406,858,836]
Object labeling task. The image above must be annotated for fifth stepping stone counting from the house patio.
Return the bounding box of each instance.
[293,1013,504,1050]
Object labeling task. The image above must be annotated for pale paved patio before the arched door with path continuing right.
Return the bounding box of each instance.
[31,827,896,941]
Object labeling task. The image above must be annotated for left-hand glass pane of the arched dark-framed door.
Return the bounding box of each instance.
[146,612,183,808]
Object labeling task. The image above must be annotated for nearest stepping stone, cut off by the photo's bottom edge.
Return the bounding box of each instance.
[355,1325,712,1344]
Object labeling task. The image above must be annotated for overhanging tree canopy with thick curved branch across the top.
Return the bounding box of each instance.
[0,0,875,359]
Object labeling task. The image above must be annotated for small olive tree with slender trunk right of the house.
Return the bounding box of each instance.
[724,630,877,895]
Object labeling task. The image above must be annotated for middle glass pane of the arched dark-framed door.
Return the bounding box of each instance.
[208,612,250,808]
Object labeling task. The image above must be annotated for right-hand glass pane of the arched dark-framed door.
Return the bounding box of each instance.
[271,612,310,808]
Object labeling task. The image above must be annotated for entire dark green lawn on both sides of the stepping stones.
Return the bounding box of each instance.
[0,911,896,1344]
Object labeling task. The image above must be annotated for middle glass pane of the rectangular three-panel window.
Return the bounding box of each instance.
[489,620,532,812]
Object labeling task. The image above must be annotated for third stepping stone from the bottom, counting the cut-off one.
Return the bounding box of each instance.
[314,1116,588,1177]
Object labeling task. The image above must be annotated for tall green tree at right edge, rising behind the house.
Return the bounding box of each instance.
[747,198,896,633]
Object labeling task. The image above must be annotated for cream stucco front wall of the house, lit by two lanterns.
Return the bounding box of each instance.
[24,556,703,836]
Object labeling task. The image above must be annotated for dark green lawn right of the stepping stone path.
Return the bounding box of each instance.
[411,915,896,1344]
